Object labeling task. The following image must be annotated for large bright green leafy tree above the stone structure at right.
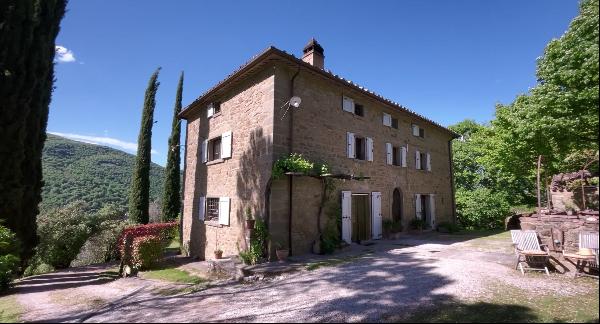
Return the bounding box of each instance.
[487,0,599,183]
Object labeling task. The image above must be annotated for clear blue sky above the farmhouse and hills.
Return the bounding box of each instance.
[48,0,578,165]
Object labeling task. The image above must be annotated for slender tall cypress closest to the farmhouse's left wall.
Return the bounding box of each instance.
[162,72,183,221]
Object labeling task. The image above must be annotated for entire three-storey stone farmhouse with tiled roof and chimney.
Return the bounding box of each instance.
[180,39,457,259]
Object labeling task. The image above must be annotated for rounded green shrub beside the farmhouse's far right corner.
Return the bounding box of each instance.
[456,188,510,229]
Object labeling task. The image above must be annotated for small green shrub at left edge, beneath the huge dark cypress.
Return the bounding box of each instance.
[0,225,21,290]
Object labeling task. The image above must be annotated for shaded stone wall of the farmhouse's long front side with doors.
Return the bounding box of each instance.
[271,65,453,253]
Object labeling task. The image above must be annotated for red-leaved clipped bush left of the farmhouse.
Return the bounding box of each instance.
[118,222,179,270]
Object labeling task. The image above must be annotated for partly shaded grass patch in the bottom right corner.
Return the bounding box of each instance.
[390,283,599,323]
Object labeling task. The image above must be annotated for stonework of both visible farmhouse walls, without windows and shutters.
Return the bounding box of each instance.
[183,44,454,259]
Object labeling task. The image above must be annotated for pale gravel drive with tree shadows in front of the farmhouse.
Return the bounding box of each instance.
[10,234,598,322]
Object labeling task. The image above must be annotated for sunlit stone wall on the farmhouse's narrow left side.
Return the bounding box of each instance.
[182,69,274,259]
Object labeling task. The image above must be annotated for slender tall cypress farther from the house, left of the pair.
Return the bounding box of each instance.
[129,68,160,224]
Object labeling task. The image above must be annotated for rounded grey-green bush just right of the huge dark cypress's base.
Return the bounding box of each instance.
[37,202,94,269]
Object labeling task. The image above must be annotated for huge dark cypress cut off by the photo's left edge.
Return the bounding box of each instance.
[0,0,67,262]
